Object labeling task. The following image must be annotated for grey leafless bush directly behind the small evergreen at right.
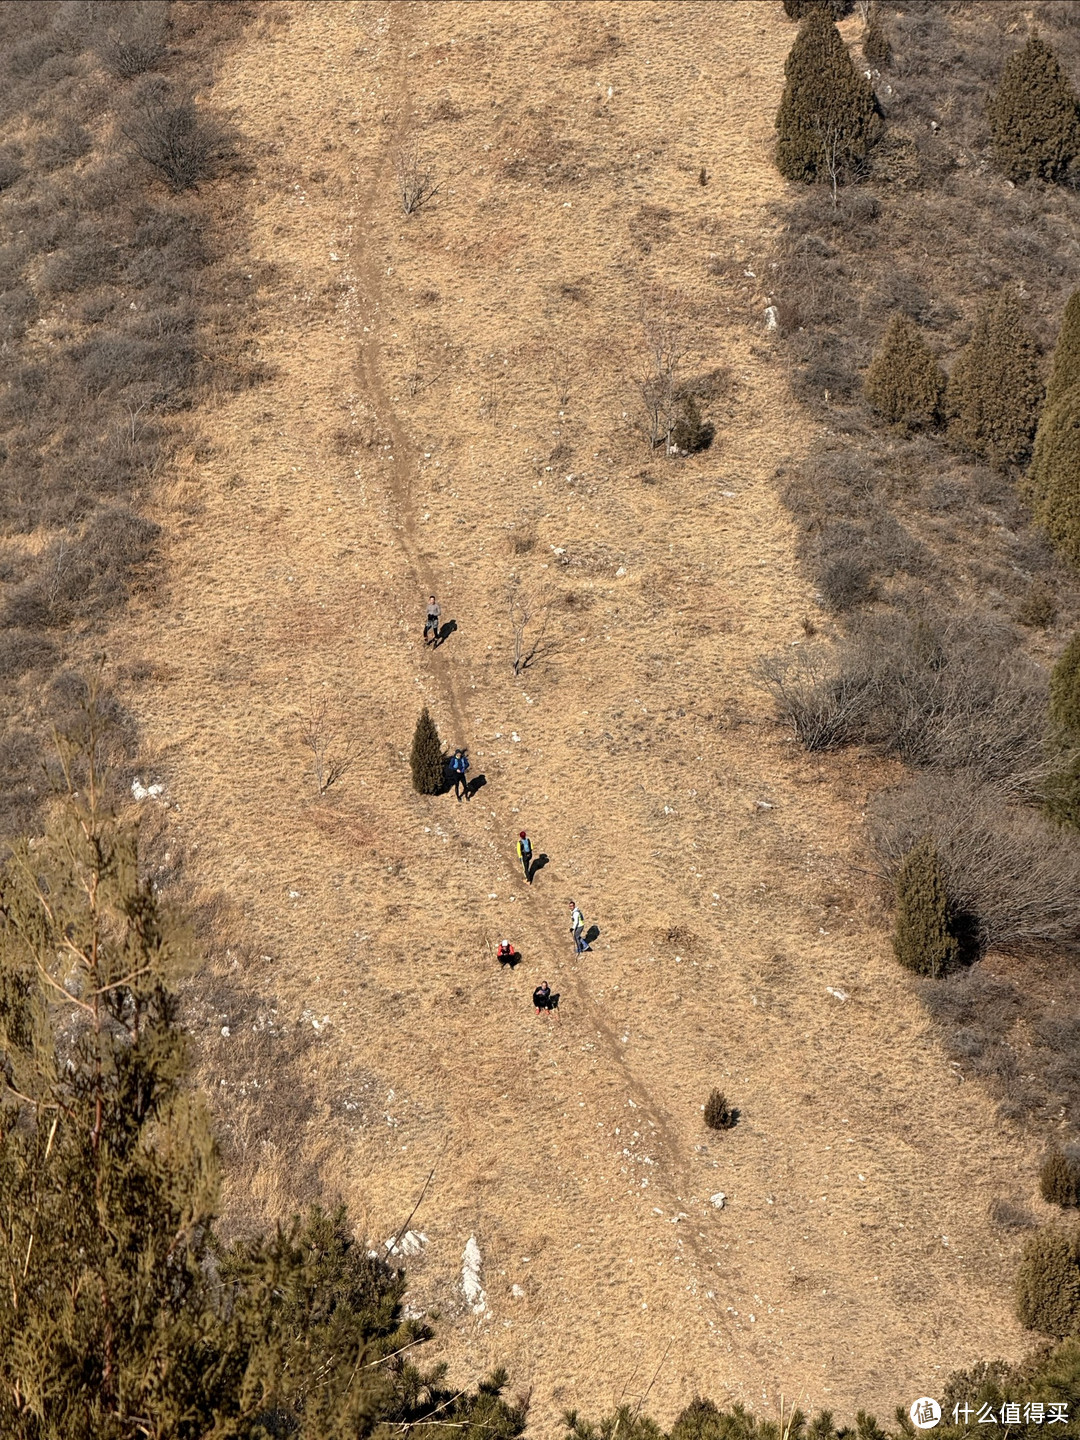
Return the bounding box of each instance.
[870,773,1080,948]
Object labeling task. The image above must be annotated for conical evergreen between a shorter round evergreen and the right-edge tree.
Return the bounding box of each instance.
[946,287,1043,469]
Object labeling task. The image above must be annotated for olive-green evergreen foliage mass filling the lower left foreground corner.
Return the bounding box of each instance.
[0,708,524,1440]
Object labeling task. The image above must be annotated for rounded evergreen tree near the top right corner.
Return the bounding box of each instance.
[986,35,1080,184]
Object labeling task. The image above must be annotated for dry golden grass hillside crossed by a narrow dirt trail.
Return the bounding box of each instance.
[117,0,1038,1436]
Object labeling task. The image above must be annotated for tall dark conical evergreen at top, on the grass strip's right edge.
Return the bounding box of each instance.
[776,7,880,183]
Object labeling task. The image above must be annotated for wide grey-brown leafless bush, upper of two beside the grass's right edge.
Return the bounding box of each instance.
[762,618,1048,795]
